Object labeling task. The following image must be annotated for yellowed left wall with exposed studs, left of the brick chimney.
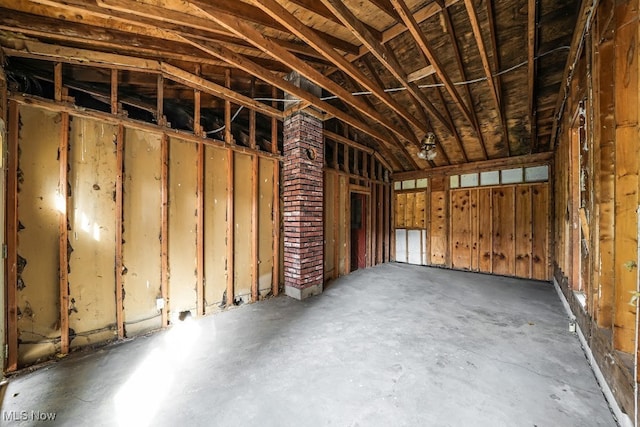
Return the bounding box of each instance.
[9,97,279,366]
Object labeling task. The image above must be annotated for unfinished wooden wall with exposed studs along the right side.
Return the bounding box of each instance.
[553,0,640,414]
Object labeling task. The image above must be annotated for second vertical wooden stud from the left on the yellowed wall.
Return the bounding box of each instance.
[56,112,69,354]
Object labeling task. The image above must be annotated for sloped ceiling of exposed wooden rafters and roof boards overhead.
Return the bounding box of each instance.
[0,0,580,171]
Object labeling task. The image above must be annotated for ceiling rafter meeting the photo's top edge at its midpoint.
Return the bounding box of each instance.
[322,0,452,132]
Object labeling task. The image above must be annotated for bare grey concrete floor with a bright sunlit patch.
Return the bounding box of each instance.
[0,264,616,427]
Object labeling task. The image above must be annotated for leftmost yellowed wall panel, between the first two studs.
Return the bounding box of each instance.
[14,107,60,363]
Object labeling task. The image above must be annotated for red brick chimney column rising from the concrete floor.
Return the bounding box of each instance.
[283,75,324,300]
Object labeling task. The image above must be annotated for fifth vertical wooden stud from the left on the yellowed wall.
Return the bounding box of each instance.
[196,144,206,316]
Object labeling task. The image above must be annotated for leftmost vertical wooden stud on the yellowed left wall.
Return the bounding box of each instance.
[6,101,20,372]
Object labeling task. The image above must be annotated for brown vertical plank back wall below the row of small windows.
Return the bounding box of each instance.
[395,177,551,280]
